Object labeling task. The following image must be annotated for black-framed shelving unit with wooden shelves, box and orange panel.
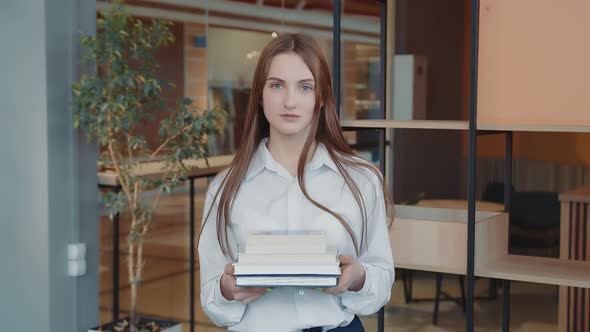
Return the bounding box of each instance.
[335,0,590,332]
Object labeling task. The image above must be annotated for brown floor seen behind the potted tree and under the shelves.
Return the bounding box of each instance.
[98,180,557,332]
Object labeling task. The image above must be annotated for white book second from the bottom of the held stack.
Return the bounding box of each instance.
[233,263,340,275]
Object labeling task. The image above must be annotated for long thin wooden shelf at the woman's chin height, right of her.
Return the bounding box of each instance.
[340,120,469,130]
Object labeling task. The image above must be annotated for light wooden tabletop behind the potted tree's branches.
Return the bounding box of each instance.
[96,155,234,186]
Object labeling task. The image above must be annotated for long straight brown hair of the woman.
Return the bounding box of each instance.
[199,34,393,259]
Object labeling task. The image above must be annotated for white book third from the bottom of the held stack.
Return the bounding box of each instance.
[238,253,338,265]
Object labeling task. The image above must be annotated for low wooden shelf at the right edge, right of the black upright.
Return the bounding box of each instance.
[475,255,590,288]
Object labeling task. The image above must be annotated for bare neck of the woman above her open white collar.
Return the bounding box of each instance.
[267,132,317,176]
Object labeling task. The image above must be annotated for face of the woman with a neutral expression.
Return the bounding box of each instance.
[262,53,316,140]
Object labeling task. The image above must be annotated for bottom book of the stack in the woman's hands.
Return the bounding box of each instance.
[236,276,338,287]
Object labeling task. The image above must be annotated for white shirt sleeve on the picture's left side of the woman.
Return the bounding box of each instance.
[198,187,246,326]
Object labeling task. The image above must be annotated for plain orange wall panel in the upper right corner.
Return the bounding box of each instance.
[477,0,590,125]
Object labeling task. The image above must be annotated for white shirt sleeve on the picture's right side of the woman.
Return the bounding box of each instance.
[342,172,395,315]
